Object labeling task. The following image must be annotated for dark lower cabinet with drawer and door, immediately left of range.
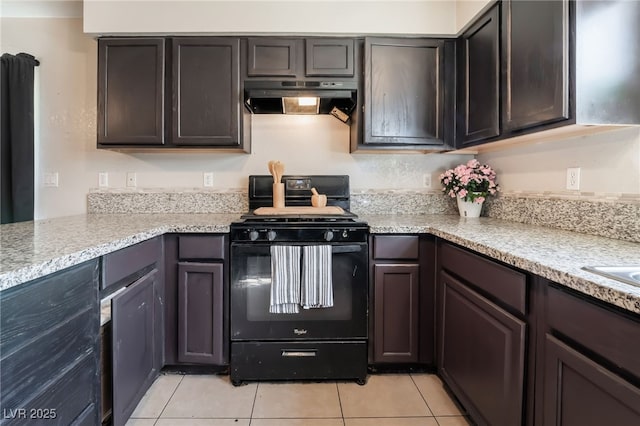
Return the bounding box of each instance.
[164,234,229,366]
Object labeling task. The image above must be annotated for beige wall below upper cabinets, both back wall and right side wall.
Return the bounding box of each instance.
[0,7,640,218]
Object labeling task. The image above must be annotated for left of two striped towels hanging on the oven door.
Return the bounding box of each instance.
[269,245,300,314]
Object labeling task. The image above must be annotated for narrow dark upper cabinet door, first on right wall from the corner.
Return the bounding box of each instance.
[457,5,500,146]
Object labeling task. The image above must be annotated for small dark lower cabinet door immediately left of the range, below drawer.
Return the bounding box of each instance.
[178,262,227,365]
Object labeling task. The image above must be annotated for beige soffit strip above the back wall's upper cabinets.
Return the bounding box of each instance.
[84,0,456,35]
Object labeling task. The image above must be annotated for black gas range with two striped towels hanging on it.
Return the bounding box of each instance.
[230,175,368,384]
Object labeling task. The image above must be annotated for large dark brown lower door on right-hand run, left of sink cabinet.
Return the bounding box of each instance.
[438,271,526,426]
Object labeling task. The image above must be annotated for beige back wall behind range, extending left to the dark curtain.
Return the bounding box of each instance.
[0,18,469,218]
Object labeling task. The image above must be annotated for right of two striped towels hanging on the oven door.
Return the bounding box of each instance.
[300,245,333,309]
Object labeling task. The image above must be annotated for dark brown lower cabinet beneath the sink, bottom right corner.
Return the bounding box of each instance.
[536,282,640,426]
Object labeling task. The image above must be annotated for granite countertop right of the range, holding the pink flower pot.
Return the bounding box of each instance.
[360,215,640,313]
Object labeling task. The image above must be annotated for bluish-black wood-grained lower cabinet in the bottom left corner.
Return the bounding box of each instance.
[0,259,100,426]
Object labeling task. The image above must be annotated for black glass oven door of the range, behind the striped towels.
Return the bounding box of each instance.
[230,243,368,341]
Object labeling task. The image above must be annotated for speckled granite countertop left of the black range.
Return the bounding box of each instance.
[0,213,240,290]
